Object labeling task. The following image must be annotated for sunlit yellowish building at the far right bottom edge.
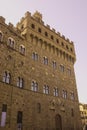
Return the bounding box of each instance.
[79,103,87,130]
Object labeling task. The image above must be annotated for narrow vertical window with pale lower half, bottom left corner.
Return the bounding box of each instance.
[1,104,7,127]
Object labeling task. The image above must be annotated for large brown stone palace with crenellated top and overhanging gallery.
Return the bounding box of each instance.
[0,11,81,130]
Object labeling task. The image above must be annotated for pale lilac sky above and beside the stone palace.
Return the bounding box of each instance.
[0,0,87,104]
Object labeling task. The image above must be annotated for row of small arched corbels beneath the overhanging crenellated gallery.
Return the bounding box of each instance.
[30,34,75,63]
